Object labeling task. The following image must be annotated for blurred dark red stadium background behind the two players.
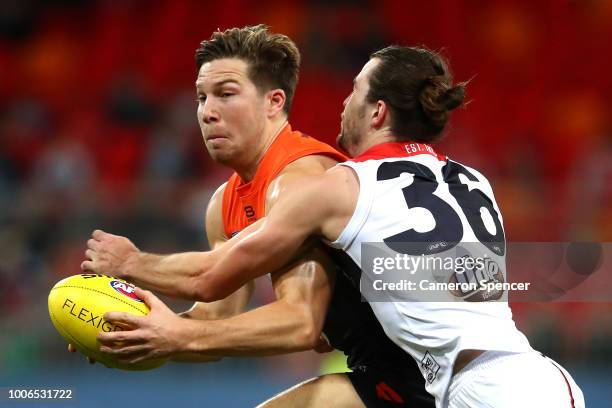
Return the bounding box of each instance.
[0,0,612,407]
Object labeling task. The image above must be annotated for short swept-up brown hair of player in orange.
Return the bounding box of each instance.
[195,24,300,114]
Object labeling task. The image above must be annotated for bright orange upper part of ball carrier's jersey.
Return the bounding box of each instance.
[222,124,347,238]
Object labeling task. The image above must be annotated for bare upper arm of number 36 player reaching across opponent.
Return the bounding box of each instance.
[194,167,359,301]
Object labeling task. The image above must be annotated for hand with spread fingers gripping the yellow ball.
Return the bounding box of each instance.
[97,288,189,363]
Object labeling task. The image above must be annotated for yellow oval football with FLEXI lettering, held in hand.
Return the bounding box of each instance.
[49,274,166,370]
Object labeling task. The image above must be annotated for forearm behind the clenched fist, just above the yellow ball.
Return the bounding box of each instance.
[121,252,212,300]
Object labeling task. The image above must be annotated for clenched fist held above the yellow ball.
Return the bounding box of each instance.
[81,230,139,278]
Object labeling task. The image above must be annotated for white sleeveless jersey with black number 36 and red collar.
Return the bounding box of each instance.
[330,142,531,407]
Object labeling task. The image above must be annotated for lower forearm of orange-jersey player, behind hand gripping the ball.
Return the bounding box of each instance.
[183,300,321,357]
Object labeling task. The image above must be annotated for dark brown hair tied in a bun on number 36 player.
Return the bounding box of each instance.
[367,45,466,143]
